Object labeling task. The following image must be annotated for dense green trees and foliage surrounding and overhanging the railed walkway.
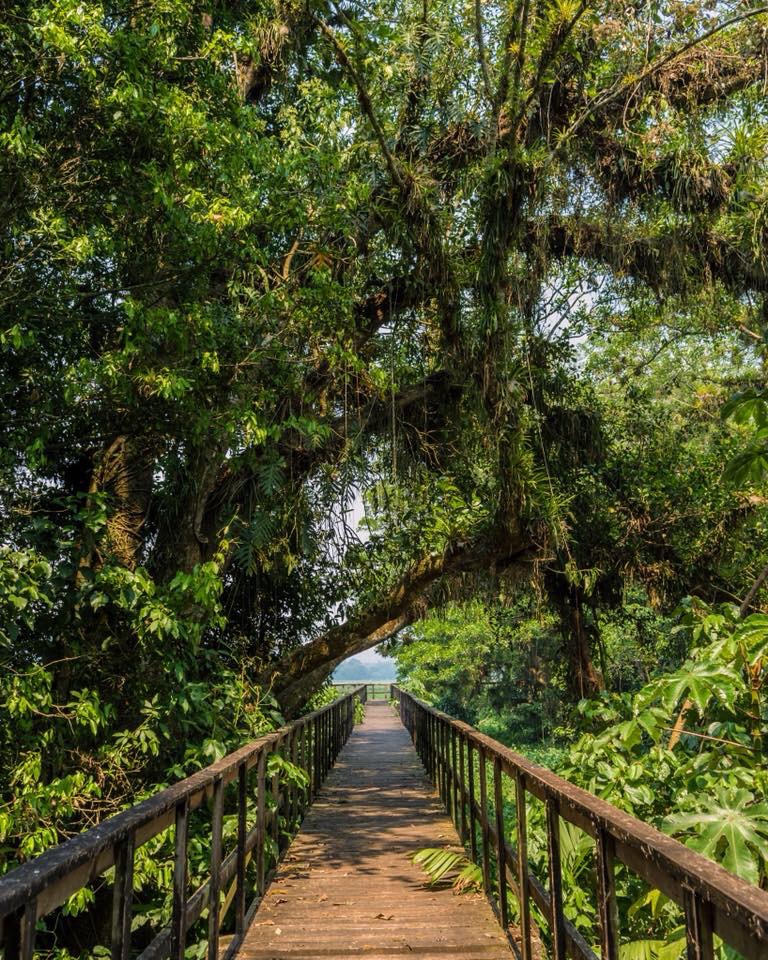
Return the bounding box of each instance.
[0,0,768,960]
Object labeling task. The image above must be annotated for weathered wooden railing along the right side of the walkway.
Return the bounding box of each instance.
[393,686,768,960]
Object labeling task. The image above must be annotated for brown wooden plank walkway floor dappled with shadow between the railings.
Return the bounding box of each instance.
[238,703,512,960]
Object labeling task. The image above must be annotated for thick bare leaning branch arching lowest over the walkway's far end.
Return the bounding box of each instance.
[265,533,531,714]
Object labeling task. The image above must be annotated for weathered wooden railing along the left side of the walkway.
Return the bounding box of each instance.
[0,688,366,960]
